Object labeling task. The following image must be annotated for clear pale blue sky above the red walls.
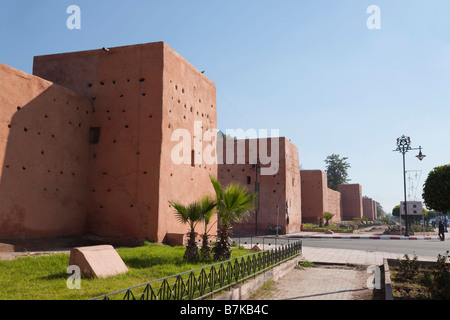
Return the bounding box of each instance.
[0,0,450,212]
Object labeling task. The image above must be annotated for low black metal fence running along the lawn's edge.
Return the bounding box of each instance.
[92,240,302,300]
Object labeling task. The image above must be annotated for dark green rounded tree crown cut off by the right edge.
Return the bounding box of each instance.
[422,164,450,214]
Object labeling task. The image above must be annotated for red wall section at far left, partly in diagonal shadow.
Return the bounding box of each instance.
[0,84,91,239]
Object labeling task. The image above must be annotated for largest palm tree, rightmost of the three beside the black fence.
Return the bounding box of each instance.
[210,176,255,260]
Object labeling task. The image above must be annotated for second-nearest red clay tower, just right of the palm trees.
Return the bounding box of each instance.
[218,138,302,235]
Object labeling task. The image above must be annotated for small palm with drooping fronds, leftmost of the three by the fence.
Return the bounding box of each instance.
[169,197,216,260]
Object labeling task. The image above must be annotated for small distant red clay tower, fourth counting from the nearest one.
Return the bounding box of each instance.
[339,184,363,220]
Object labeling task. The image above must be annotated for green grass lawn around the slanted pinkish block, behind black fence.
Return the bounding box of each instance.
[0,243,249,300]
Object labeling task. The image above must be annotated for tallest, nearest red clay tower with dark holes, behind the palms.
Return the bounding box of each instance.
[34,42,217,242]
